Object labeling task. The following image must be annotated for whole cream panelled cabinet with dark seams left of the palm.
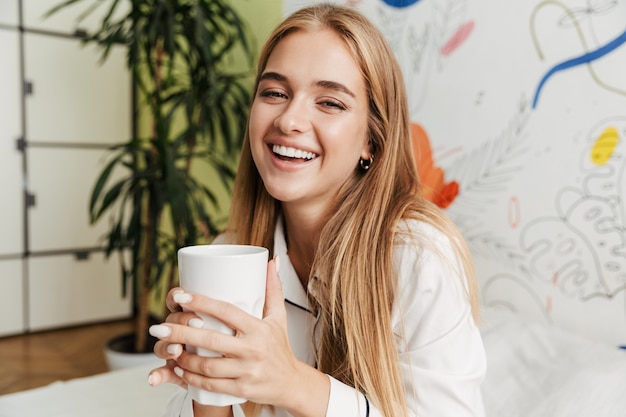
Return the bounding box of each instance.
[0,0,132,336]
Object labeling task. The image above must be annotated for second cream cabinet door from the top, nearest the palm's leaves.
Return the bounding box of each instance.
[24,33,131,144]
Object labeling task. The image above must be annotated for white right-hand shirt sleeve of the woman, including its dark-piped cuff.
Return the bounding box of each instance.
[326,226,486,417]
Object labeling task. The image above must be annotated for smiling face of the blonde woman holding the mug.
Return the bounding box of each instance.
[249,30,370,213]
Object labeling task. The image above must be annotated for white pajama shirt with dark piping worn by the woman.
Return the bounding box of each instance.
[164,220,486,417]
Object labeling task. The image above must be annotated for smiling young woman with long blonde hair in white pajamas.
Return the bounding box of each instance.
[149,5,485,417]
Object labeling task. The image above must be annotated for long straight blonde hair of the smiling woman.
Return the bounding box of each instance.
[227,4,478,417]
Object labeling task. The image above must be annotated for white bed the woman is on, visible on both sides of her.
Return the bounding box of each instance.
[0,309,626,417]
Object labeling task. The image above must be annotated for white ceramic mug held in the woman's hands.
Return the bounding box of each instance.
[178,245,269,406]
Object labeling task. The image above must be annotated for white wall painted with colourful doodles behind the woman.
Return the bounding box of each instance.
[284,0,626,346]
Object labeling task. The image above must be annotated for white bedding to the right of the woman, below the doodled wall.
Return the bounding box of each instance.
[482,310,626,417]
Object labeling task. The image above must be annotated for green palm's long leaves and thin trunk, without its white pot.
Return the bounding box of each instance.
[48,0,253,360]
